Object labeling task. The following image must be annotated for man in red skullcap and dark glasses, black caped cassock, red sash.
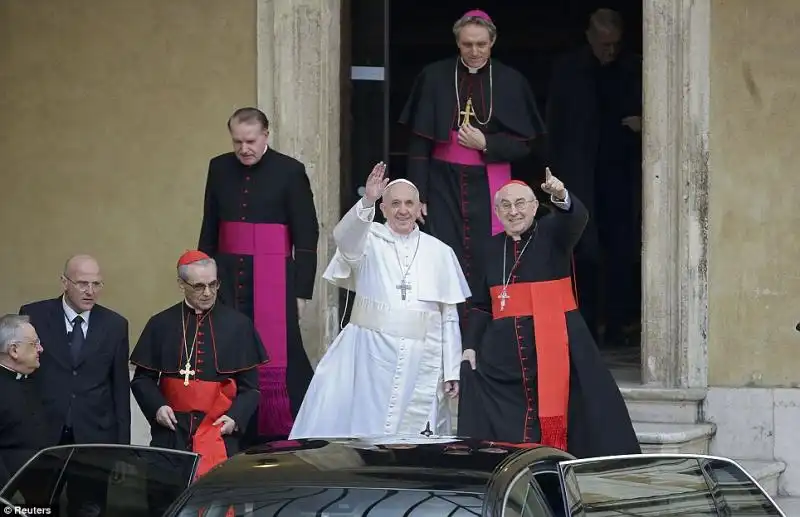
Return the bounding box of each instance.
[131,251,268,496]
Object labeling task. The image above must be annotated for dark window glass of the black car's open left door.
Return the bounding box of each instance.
[0,445,197,517]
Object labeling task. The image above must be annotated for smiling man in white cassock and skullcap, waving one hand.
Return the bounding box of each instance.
[289,162,471,439]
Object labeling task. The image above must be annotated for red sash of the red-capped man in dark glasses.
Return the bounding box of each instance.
[159,377,236,477]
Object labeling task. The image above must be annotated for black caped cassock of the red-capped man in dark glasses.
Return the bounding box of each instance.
[131,302,268,456]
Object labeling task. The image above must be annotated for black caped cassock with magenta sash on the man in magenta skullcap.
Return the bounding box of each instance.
[400,57,544,322]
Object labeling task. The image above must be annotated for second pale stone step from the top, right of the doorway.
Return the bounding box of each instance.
[633,422,717,454]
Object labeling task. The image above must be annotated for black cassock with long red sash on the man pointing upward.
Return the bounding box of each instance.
[458,195,640,457]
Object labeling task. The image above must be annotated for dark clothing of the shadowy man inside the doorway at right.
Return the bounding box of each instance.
[547,45,642,342]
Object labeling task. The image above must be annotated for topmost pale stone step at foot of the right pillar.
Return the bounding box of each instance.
[619,383,706,424]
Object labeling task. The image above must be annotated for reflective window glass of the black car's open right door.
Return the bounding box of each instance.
[564,455,780,517]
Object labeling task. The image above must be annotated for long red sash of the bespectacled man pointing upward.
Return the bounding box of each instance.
[490,278,577,450]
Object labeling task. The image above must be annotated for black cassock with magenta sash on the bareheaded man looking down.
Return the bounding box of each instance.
[198,149,319,441]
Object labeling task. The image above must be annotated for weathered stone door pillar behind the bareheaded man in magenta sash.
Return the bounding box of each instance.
[257,0,342,364]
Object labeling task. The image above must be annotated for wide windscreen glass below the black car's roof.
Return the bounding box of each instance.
[176,486,483,517]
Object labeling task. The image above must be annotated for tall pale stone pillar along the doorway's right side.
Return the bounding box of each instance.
[642,0,711,387]
